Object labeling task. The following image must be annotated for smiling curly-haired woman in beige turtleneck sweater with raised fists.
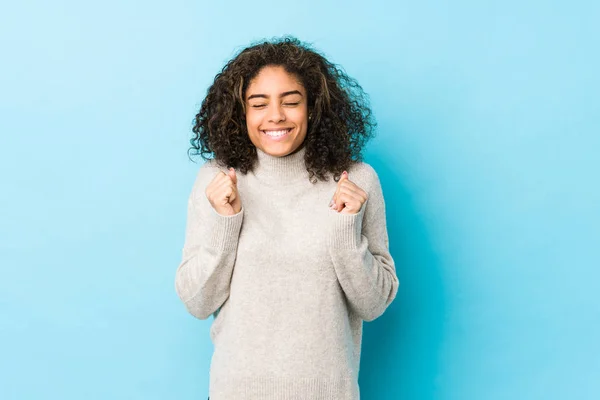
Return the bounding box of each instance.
[176,37,398,400]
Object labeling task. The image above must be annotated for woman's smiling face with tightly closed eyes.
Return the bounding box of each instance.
[245,66,308,157]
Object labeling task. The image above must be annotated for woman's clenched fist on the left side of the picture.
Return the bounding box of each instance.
[205,168,242,216]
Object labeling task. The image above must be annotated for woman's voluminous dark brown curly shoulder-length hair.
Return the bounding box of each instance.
[188,36,376,183]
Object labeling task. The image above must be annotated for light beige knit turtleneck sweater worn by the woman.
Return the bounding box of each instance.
[175,148,398,400]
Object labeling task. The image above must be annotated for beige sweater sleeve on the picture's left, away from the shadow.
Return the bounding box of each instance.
[175,164,244,319]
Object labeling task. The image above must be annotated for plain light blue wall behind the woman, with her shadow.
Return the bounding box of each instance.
[0,0,600,400]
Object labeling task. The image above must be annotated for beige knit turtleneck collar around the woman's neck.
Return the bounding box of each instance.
[254,144,308,185]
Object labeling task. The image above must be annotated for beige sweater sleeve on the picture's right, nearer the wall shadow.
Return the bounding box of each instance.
[329,167,398,321]
